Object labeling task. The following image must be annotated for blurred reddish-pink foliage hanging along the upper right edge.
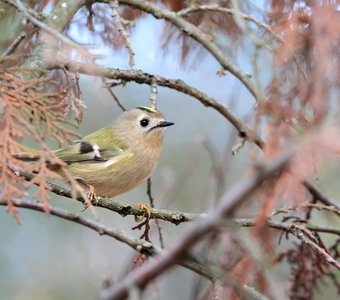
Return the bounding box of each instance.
[258,1,340,225]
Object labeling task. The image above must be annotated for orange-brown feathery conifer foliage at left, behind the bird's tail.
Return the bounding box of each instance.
[0,60,82,220]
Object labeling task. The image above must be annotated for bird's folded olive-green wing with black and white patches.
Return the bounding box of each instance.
[55,128,127,163]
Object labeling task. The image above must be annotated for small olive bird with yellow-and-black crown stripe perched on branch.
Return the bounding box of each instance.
[18,106,174,200]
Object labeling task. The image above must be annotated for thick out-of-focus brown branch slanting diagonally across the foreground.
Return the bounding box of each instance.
[101,146,293,300]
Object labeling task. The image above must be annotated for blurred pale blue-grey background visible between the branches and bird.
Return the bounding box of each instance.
[0,1,340,300]
